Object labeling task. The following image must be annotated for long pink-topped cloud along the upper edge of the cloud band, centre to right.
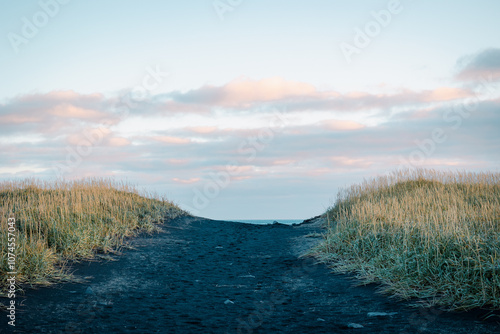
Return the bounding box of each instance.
[167,77,471,111]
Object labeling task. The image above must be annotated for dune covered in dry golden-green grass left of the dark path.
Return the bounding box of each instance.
[0,179,186,291]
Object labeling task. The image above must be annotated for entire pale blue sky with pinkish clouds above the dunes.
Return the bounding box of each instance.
[0,0,500,220]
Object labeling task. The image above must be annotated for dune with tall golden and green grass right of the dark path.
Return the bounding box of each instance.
[314,170,500,310]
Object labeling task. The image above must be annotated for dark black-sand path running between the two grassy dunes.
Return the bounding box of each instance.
[0,217,500,334]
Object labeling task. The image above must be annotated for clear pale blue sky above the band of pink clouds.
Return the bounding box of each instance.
[0,0,500,98]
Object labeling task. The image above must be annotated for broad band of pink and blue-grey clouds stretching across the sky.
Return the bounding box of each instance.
[0,53,500,218]
